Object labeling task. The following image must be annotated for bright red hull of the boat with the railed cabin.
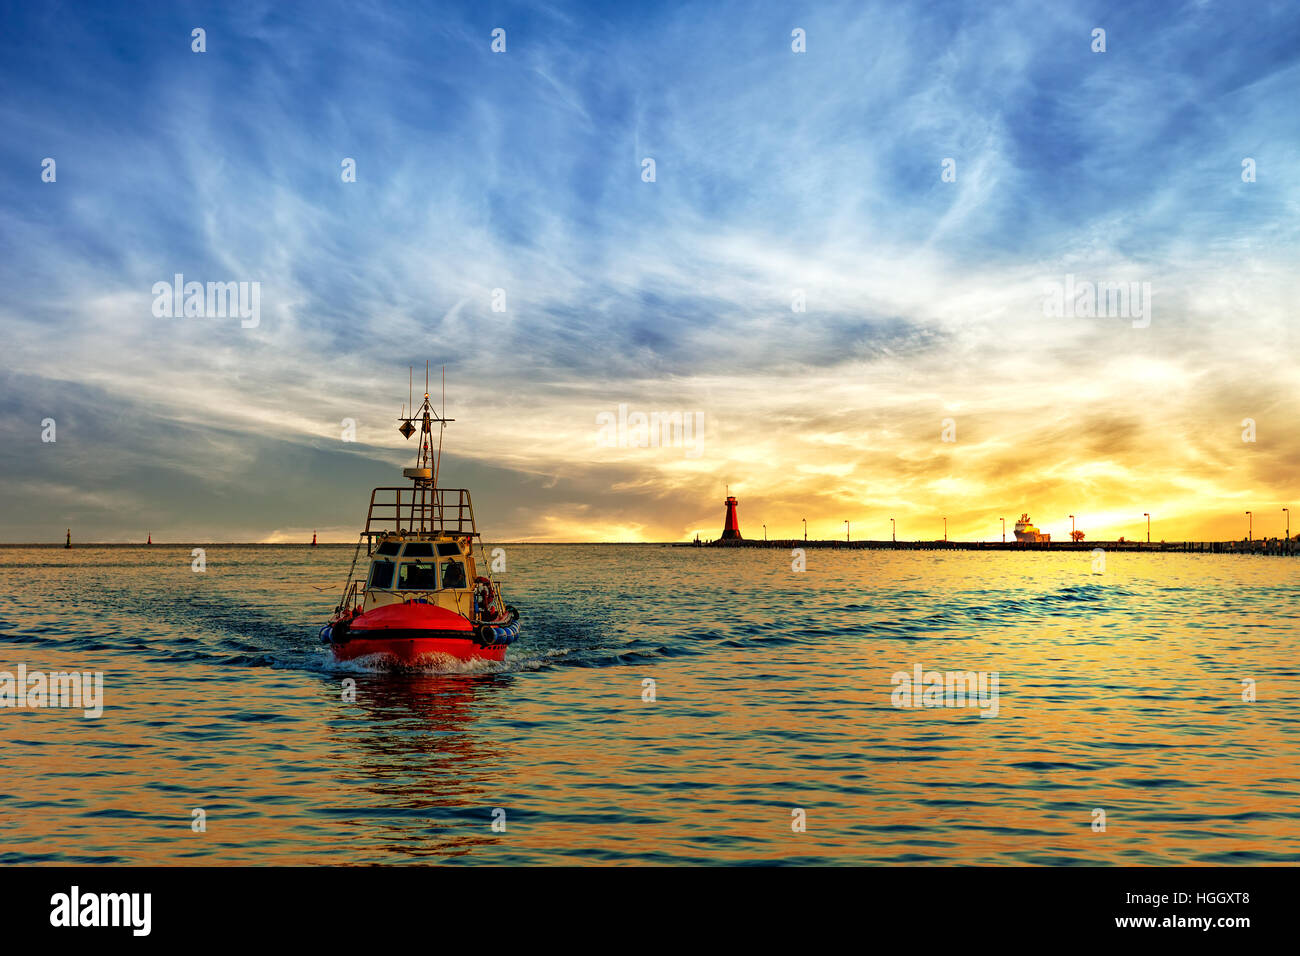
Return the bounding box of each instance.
[332,602,506,665]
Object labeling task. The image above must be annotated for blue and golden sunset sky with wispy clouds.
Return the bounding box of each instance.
[0,0,1300,542]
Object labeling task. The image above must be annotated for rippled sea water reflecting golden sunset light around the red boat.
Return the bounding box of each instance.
[0,545,1300,865]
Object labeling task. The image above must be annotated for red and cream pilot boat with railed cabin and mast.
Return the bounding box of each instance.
[320,377,519,666]
